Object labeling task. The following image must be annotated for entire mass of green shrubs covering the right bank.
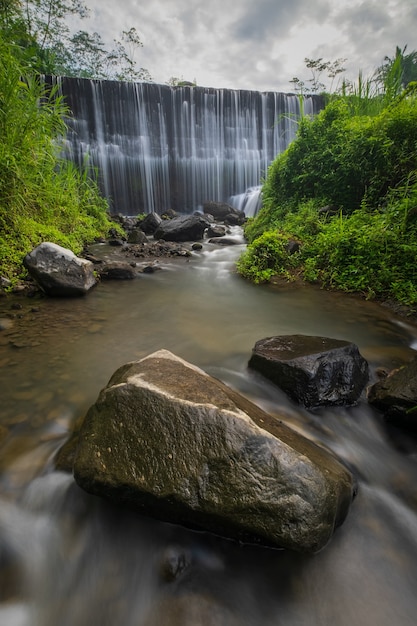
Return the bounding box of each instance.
[238,85,417,305]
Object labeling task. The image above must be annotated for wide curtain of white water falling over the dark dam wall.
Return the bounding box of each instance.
[54,77,323,215]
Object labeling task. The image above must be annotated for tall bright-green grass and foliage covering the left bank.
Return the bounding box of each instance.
[0,42,110,286]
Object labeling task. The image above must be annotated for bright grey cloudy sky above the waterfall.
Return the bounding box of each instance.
[70,0,417,92]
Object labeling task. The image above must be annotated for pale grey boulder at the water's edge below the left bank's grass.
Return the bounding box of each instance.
[23,241,97,296]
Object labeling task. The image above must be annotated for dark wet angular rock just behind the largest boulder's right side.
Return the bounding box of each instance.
[248,335,368,408]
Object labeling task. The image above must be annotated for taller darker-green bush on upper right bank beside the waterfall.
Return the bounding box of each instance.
[262,94,417,214]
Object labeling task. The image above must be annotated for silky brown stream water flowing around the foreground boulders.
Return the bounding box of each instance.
[0,235,417,626]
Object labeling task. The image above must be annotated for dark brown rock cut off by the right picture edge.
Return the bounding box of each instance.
[368,357,417,431]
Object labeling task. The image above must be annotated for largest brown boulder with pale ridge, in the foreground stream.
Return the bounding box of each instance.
[69,350,354,552]
